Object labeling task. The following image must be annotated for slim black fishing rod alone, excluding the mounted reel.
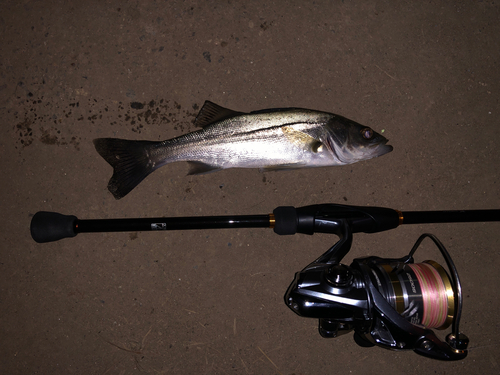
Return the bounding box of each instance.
[31,204,500,243]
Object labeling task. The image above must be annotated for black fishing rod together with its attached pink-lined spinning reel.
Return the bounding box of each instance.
[31,204,500,360]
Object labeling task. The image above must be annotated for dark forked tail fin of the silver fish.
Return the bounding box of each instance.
[94,138,159,199]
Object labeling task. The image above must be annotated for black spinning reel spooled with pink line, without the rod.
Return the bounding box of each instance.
[285,220,468,360]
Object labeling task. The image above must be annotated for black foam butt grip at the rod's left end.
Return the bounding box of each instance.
[30,211,78,243]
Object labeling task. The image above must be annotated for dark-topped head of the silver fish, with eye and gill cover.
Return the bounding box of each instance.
[327,116,393,164]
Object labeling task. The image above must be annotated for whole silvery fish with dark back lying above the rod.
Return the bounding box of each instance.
[93,101,393,199]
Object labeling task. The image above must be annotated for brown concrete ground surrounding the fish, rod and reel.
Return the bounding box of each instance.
[0,0,500,375]
